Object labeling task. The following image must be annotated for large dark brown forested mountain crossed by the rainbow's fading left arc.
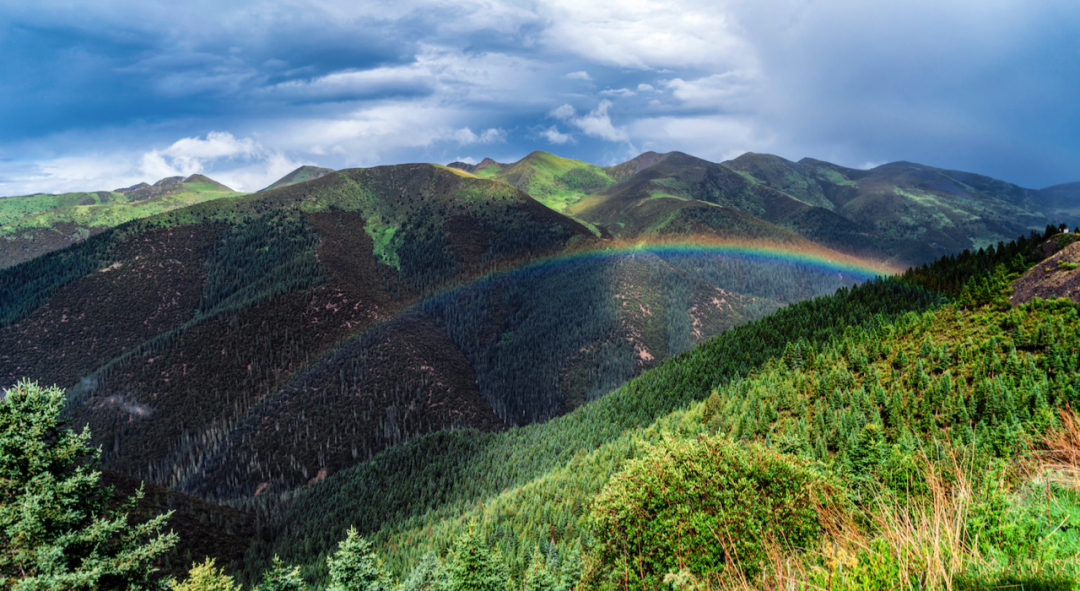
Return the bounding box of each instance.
[0,158,868,514]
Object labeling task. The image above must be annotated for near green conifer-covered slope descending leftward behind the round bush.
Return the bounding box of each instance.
[247,234,1080,587]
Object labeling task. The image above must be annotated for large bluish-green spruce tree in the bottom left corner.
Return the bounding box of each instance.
[0,380,177,591]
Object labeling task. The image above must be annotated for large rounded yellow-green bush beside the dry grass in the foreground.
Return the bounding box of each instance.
[586,438,831,589]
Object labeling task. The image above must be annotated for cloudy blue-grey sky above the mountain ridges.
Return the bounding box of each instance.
[0,0,1080,196]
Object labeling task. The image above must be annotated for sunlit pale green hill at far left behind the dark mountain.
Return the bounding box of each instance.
[0,175,244,268]
